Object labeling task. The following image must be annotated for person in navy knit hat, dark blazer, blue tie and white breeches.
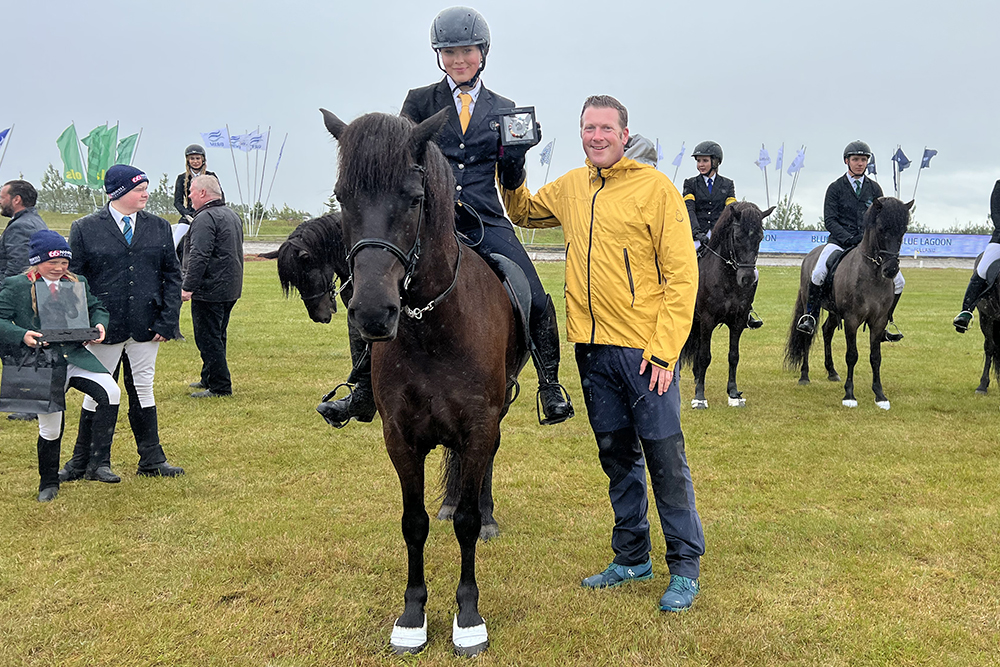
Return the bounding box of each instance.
[60,164,184,481]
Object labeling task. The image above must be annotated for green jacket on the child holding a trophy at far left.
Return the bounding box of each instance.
[0,274,109,373]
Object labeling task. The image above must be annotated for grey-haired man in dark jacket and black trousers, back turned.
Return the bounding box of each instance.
[181,176,243,398]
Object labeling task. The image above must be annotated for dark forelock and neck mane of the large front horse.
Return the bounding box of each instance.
[337,113,455,231]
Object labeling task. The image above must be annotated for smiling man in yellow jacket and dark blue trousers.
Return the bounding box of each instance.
[499,95,705,611]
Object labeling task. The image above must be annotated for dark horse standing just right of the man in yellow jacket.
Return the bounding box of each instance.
[681,202,774,409]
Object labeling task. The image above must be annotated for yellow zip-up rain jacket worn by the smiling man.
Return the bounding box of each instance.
[500,158,698,370]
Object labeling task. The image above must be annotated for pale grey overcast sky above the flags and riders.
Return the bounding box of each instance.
[0,0,1000,228]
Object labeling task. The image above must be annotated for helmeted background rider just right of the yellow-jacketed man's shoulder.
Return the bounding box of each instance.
[684,141,764,329]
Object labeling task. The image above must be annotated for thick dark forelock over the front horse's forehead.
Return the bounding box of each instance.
[337,113,413,192]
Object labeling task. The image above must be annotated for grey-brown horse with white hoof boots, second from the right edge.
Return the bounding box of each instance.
[785,197,913,410]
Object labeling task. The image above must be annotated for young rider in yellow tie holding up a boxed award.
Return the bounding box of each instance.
[318,7,573,426]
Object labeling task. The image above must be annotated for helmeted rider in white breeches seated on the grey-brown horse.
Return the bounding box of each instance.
[795,140,906,343]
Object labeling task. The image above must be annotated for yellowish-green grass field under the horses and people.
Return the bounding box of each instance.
[0,262,1000,667]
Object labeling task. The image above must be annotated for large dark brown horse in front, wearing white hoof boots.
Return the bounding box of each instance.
[323,110,527,655]
